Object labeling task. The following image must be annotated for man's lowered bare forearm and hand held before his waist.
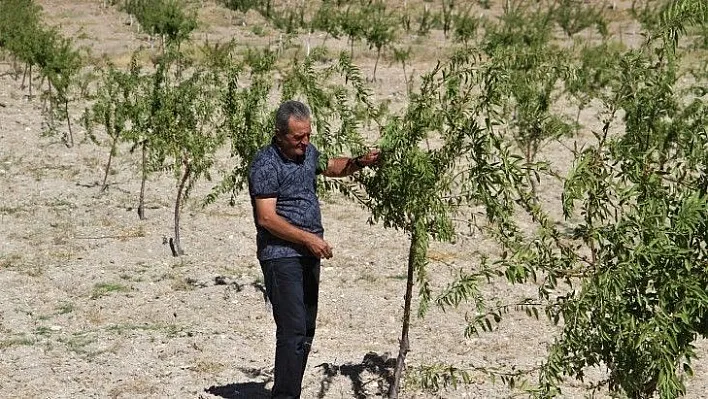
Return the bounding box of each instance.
[255,198,332,259]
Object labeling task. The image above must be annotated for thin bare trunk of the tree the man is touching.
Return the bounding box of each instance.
[388,224,427,399]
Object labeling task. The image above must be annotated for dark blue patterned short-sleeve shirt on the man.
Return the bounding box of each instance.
[248,142,324,260]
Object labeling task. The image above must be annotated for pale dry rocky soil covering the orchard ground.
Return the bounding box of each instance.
[0,0,708,398]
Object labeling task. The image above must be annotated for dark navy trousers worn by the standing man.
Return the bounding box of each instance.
[261,257,320,399]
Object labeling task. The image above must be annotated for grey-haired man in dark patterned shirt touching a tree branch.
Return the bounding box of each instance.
[249,101,379,399]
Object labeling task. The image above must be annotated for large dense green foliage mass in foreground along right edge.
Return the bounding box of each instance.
[478,0,708,398]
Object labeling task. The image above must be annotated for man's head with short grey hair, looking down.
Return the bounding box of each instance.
[275,100,312,159]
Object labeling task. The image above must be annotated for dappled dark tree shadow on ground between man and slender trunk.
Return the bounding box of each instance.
[316,352,396,399]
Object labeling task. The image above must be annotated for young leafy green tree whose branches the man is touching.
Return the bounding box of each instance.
[360,52,524,398]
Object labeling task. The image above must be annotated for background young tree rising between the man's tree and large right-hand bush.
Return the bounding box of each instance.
[483,1,573,195]
